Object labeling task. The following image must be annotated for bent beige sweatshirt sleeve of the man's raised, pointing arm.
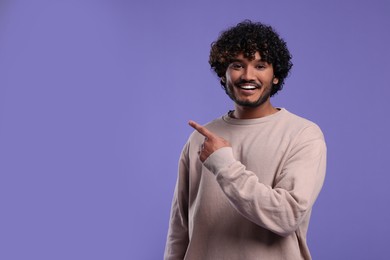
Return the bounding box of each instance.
[204,126,326,236]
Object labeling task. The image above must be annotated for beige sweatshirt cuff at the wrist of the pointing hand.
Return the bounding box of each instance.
[203,147,236,175]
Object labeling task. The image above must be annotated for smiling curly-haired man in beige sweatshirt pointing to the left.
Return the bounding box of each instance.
[165,21,326,260]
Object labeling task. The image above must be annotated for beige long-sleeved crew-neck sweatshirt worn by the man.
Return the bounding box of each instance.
[164,109,326,260]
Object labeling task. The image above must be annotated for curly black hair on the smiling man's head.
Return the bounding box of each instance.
[209,20,293,96]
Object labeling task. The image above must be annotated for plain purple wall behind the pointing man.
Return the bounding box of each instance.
[0,0,390,260]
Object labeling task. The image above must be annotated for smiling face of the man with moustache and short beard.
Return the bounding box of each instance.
[222,52,278,107]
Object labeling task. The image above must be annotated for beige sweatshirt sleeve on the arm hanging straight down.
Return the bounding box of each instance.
[164,144,189,260]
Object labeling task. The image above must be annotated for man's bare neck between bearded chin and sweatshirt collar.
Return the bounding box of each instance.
[231,103,279,119]
